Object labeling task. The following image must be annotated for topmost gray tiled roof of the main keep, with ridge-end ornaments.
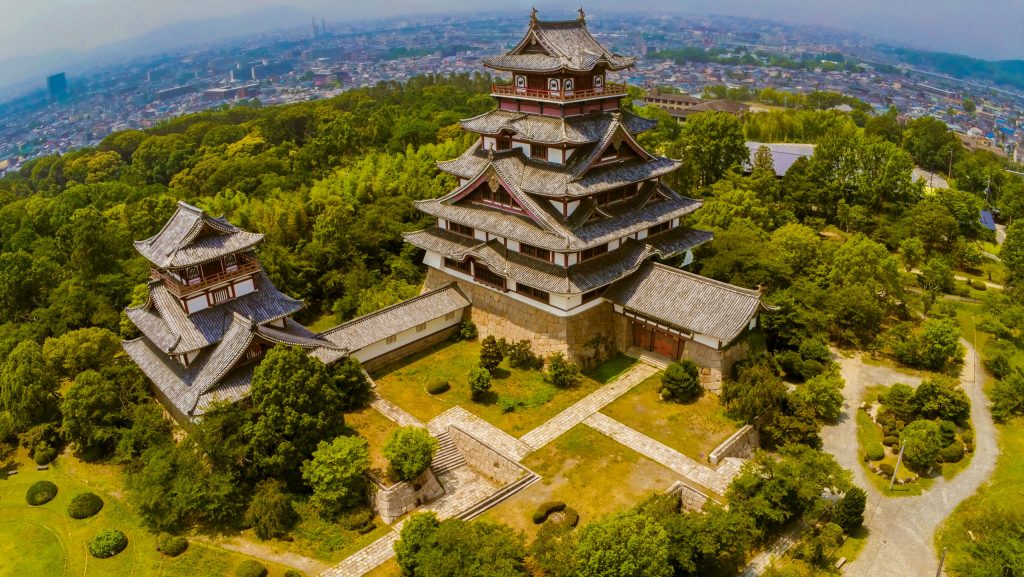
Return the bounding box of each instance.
[483,19,636,72]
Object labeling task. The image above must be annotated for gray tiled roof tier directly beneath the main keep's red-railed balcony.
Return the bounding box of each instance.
[460,110,657,145]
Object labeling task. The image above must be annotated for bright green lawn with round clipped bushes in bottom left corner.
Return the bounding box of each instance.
[0,449,296,577]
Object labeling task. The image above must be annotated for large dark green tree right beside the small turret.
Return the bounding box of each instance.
[248,345,348,483]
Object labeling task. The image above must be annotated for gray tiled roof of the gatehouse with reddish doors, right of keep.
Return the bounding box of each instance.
[604,262,761,343]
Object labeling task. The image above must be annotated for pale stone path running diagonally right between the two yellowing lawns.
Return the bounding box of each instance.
[583,413,742,495]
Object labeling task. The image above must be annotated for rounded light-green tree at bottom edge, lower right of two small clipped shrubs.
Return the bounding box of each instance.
[574,512,672,577]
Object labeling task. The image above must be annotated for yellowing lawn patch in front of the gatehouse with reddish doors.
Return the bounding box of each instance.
[601,373,741,462]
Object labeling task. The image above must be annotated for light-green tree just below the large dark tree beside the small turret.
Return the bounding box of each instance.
[302,437,370,517]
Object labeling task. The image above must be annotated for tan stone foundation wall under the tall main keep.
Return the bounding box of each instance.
[423,267,614,366]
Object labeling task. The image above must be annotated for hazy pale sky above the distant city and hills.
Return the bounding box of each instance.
[0,0,1024,61]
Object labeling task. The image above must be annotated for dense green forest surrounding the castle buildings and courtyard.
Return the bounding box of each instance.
[0,75,1024,576]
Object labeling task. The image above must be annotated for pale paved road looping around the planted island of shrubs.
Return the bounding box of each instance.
[822,341,998,577]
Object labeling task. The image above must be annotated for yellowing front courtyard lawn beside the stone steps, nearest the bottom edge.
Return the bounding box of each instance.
[480,424,680,539]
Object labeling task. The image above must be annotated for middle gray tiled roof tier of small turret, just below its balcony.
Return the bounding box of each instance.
[125,271,303,354]
